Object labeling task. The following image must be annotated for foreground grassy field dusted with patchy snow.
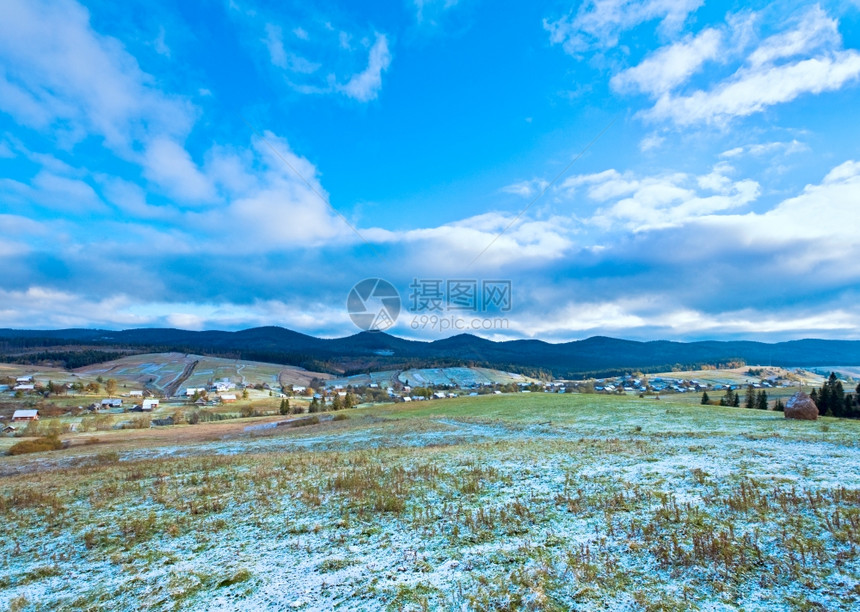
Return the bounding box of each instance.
[0,393,860,610]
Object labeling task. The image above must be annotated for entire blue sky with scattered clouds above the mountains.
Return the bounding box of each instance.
[0,0,860,341]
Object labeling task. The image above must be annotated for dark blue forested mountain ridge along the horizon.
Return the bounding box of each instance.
[0,327,860,377]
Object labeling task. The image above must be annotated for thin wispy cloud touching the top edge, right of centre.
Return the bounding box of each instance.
[544,0,704,55]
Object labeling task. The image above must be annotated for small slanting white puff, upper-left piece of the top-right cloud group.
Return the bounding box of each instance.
[610,28,722,96]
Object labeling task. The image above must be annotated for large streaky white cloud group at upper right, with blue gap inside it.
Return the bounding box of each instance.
[611,6,860,126]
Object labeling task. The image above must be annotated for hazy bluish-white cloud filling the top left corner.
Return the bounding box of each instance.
[0,0,192,151]
